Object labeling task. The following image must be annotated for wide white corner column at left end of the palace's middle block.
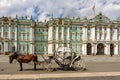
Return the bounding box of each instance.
[48,26,53,55]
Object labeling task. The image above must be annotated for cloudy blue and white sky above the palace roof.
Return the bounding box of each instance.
[0,0,120,21]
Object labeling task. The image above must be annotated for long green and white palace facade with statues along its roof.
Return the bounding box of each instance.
[0,12,120,55]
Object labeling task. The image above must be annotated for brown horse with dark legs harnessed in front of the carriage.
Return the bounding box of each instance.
[9,52,38,71]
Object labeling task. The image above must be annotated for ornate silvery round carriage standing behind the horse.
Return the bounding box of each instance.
[50,47,86,70]
